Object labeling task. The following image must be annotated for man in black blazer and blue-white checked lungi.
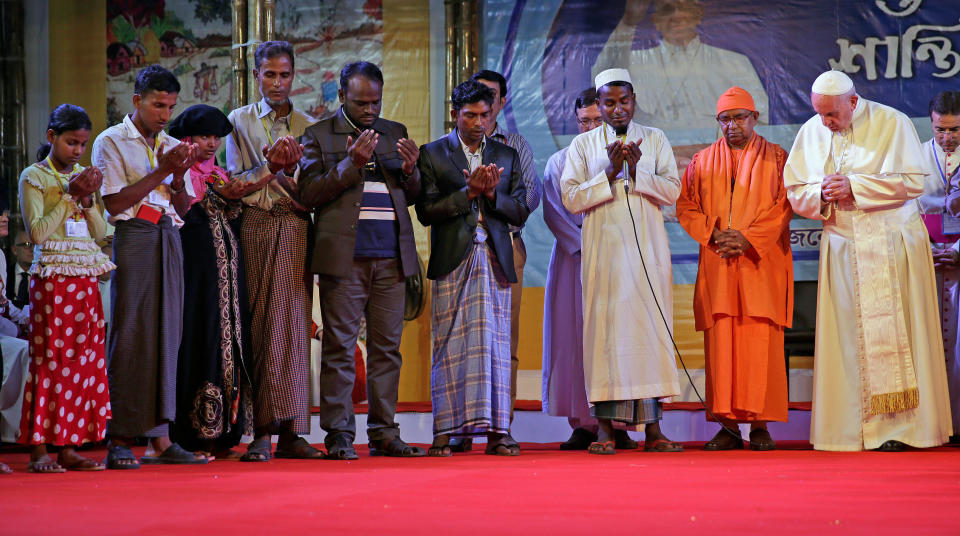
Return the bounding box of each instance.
[416,81,530,456]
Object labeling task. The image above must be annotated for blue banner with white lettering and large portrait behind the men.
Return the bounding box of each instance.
[482,0,960,286]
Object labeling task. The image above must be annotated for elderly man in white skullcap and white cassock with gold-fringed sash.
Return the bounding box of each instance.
[784,71,951,451]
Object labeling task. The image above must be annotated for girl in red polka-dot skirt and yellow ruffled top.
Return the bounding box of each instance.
[19,104,116,473]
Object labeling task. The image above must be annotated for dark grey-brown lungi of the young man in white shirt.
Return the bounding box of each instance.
[107,216,183,437]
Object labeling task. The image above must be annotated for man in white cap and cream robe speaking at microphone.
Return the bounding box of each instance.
[560,69,683,454]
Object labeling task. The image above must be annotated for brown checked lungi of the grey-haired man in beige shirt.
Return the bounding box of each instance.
[240,198,312,434]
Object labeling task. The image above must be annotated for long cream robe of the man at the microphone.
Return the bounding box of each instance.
[560,123,680,403]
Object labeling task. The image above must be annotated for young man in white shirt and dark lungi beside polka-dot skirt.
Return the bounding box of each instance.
[91,65,208,469]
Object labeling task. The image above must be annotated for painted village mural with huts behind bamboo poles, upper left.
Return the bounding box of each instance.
[107,0,383,124]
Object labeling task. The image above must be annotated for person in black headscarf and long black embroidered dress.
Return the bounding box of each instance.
[169,104,269,460]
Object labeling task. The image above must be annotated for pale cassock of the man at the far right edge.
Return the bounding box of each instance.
[919,138,960,434]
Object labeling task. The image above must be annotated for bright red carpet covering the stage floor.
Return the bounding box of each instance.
[0,444,960,536]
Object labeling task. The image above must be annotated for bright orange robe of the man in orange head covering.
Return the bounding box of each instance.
[677,133,793,421]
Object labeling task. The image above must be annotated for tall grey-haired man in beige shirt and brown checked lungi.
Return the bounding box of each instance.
[227,41,324,462]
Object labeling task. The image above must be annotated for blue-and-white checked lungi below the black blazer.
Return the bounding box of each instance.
[430,226,510,436]
